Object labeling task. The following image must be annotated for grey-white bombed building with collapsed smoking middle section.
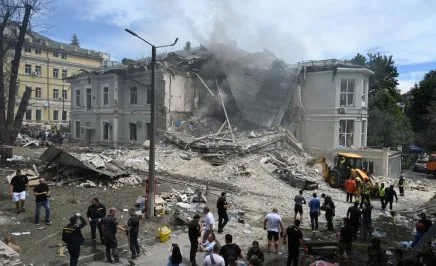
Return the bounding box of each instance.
[70,45,398,179]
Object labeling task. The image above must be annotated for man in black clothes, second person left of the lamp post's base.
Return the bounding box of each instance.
[101,208,125,263]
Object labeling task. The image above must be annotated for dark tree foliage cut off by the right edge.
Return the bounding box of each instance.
[407,70,436,150]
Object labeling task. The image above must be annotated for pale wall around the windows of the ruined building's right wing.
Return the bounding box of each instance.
[301,70,368,153]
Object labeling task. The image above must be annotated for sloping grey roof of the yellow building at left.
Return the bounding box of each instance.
[27,31,105,60]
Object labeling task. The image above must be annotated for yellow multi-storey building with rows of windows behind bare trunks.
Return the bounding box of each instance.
[15,32,108,127]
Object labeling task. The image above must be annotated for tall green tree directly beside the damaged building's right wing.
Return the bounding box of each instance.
[350,53,414,147]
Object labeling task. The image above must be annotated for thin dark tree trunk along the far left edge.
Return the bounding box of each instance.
[0,11,10,143]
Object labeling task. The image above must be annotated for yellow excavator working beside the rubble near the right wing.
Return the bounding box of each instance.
[308,153,373,188]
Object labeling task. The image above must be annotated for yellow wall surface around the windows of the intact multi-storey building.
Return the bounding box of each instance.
[15,34,102,128]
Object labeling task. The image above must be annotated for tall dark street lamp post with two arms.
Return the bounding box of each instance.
[125,29,179,218]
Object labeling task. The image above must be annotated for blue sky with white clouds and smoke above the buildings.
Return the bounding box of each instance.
[37,0,436,92]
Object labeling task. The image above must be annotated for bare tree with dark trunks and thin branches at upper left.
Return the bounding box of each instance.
[0,0,51,161]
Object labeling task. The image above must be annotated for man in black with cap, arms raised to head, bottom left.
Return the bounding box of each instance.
[62,213,86,266]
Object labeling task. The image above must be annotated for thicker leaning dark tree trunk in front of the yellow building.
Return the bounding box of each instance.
[5,4,31,143]
